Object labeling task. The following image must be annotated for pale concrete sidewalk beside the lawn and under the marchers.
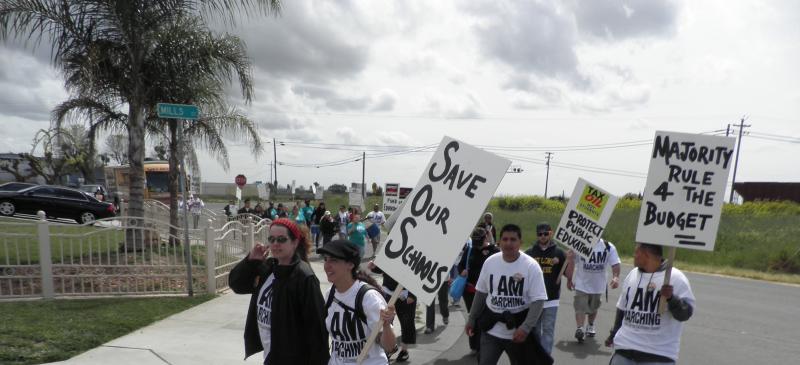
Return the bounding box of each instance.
[48,260,465,365]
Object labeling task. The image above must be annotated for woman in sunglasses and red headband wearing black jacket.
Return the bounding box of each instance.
[228,218,330,364]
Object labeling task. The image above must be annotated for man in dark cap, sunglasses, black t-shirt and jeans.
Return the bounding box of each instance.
[525,223,572,354]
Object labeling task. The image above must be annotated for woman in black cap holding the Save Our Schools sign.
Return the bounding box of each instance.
[317,240,396,365]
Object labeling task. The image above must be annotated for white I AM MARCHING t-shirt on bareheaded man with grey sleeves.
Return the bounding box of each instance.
[475,252,547,339]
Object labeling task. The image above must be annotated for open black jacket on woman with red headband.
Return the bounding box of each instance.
[228,255,330,365]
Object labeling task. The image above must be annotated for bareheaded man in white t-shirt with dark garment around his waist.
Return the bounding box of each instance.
[466,224,552,365]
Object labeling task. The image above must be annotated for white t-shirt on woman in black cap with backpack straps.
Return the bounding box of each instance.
[325,280,389,365]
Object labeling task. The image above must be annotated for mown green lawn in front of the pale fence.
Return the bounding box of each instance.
[0,295,213,364]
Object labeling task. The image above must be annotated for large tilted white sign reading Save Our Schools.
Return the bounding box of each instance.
[375,137,511,304]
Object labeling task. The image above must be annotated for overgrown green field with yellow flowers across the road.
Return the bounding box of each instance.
[490,199,800,276]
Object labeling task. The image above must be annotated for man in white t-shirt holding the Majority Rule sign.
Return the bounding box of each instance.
[606,243,695,365]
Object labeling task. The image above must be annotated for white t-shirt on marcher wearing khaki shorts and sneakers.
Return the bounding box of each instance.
[573,239,620,294]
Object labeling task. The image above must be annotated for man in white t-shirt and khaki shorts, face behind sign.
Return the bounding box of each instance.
[567,239,620,342]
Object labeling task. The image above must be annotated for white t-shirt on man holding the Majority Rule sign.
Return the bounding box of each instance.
[614,268,695,361]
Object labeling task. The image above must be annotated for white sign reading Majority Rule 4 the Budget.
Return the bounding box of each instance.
[636,131,735,251]
